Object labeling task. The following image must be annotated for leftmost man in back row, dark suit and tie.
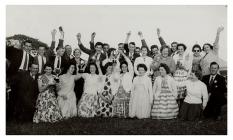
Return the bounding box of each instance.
[6,40,33,79]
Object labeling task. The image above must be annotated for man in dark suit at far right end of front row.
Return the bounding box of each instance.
[202,62,227,120]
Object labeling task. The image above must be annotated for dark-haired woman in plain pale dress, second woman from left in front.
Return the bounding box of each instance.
[57,63,79,119]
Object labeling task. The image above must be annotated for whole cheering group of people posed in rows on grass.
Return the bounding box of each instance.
[6,27,227,123]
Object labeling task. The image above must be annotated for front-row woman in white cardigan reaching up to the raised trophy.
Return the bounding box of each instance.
[113,51,134,118]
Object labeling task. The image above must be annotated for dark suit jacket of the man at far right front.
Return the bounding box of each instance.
[202,74,227,105]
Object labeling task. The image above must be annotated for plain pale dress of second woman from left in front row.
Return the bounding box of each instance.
[57,75,77,118]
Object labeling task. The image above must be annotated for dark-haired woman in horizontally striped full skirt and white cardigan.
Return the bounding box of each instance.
[151,63,179,119]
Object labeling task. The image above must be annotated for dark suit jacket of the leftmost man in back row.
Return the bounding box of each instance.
[6,47,33,76]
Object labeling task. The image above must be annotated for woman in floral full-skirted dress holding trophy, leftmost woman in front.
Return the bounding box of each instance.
[33,64,62,123]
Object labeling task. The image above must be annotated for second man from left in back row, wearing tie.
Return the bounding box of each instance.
[34,46,47,74]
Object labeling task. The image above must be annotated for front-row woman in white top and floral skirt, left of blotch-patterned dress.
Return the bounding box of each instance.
[78,61,102,118]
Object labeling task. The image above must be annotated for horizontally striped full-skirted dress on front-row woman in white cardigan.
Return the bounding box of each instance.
[151,79,179,119]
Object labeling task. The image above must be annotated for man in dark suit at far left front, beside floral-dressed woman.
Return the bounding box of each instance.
[11,64,39,122]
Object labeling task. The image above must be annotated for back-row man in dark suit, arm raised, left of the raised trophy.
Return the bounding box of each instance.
[77,33,106,71]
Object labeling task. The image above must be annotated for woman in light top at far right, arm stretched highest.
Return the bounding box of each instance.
[200,27,224,76]
